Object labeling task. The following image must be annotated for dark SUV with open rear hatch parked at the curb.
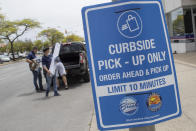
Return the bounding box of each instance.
[59,42,90,82]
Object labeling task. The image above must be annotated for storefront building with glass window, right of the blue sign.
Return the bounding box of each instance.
[162,0,196,53]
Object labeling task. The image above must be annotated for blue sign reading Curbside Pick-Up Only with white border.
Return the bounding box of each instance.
[82,0,181,130]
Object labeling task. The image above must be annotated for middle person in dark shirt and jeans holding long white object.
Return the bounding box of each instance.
[42,48,60,97]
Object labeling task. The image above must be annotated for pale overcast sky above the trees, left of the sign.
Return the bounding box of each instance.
[0,0,111,40]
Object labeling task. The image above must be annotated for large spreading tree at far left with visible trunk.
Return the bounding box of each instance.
[0,19,40,60]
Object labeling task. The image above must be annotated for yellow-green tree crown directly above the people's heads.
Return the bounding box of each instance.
[38,28,64,45]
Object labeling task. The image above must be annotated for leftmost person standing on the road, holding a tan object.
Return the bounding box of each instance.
[26,47,45,92]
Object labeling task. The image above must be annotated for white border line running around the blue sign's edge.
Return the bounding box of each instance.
[85,1,180,128]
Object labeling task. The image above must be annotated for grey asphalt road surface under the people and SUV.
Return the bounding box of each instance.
[0,62,93,131]
